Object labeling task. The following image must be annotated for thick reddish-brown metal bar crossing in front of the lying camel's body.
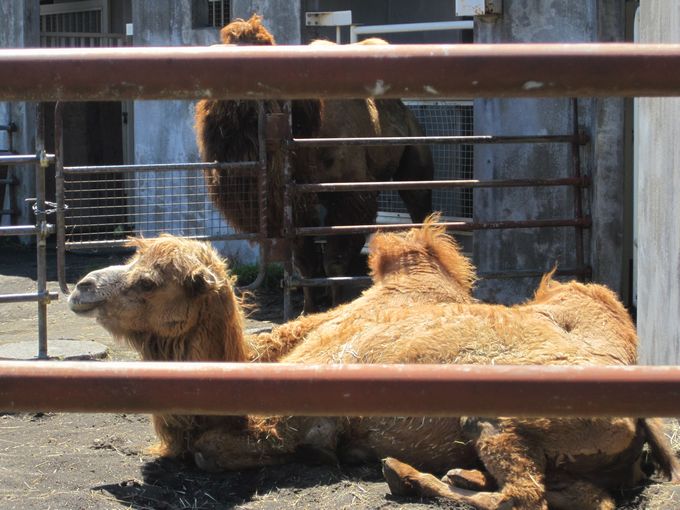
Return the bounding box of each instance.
[0,361,680,417]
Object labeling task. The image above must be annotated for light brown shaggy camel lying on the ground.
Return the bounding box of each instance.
[69,225,676,509]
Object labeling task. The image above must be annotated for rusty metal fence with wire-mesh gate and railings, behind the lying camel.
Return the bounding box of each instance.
[55,95,590,319]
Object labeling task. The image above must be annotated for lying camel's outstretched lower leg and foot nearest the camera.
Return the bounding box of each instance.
[382,457,514,510]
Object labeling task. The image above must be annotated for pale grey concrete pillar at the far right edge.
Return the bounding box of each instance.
[636,0,680,364]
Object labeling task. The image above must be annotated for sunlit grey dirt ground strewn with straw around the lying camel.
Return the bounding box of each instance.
[0,244,680,510]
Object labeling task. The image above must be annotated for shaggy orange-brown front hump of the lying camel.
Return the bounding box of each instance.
[368,213,477,296]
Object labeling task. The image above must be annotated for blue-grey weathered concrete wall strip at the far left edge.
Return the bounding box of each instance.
[0,0,40,228]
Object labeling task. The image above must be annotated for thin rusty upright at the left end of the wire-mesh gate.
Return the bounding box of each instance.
[54,101,69,294]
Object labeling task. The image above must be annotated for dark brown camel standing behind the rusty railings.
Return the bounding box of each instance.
[195,15,434,313]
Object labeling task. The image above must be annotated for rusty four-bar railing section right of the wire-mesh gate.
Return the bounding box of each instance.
[283,98,591,314]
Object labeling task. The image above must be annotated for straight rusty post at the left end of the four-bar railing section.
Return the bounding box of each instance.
[281,101,295,321]
